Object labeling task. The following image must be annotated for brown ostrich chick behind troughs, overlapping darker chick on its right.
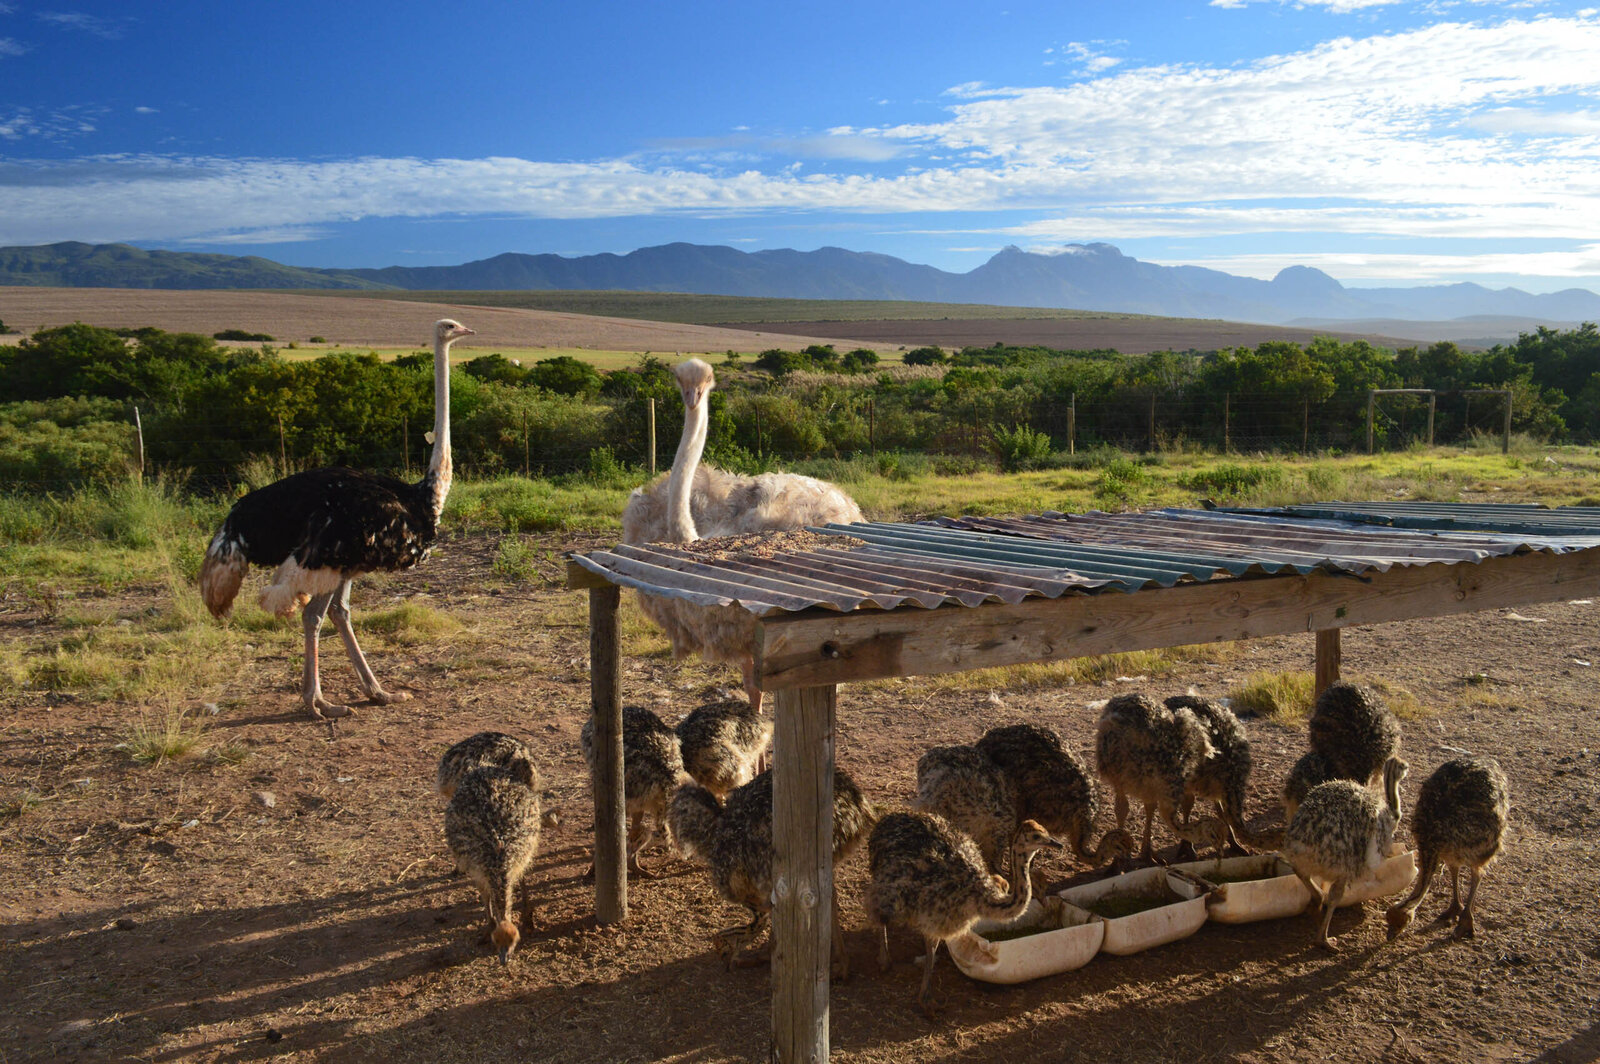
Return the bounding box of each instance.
[1094,694,1227,861]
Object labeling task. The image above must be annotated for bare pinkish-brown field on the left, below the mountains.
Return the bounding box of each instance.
[0,286,864,354]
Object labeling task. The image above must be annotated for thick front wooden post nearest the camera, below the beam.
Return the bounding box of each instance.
[773,686,838,1064]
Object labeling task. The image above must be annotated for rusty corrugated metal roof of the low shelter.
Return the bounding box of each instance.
[573,504,1600,616]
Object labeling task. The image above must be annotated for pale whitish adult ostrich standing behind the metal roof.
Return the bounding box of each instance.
[622,358,862,709]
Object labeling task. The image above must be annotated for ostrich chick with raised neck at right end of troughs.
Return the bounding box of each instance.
[1283,757,1406,950]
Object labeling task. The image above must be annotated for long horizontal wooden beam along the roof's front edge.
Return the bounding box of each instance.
[757,549,1600,691]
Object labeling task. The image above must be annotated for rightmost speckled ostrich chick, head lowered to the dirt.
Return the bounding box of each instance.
[1387,757,1510,939]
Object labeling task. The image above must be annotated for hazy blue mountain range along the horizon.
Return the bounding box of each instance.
[0,242,1600,325]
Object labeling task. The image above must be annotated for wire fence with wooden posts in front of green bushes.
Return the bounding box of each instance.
[0,389,1509,493]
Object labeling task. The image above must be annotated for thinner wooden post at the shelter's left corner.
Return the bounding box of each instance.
[589,584,627,923]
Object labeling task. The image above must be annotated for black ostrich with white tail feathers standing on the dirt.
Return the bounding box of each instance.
[200,318,472,718]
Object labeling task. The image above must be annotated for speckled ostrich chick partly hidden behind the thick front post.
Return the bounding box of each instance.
[667,768,875,979]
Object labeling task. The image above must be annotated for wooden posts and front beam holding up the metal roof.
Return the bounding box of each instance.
[568,547,1600,1064]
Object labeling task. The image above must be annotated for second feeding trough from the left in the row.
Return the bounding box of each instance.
[1059,867,1206,955]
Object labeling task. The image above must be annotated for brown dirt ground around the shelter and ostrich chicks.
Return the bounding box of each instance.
[0,536,1600,1064]
